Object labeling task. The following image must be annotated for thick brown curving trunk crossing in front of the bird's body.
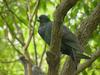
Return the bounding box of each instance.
[47,0,77,75]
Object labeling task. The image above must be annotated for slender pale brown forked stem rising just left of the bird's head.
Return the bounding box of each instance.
[23,0,40,75]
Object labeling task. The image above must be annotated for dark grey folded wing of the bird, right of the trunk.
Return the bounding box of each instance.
[62,26,80,50]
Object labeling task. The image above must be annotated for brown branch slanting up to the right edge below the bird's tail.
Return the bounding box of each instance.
[76,49,100,74]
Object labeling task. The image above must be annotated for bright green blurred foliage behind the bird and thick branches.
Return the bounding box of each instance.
[0,0,100,75]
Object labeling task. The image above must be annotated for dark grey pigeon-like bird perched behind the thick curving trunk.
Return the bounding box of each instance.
[38,15,90,60]
